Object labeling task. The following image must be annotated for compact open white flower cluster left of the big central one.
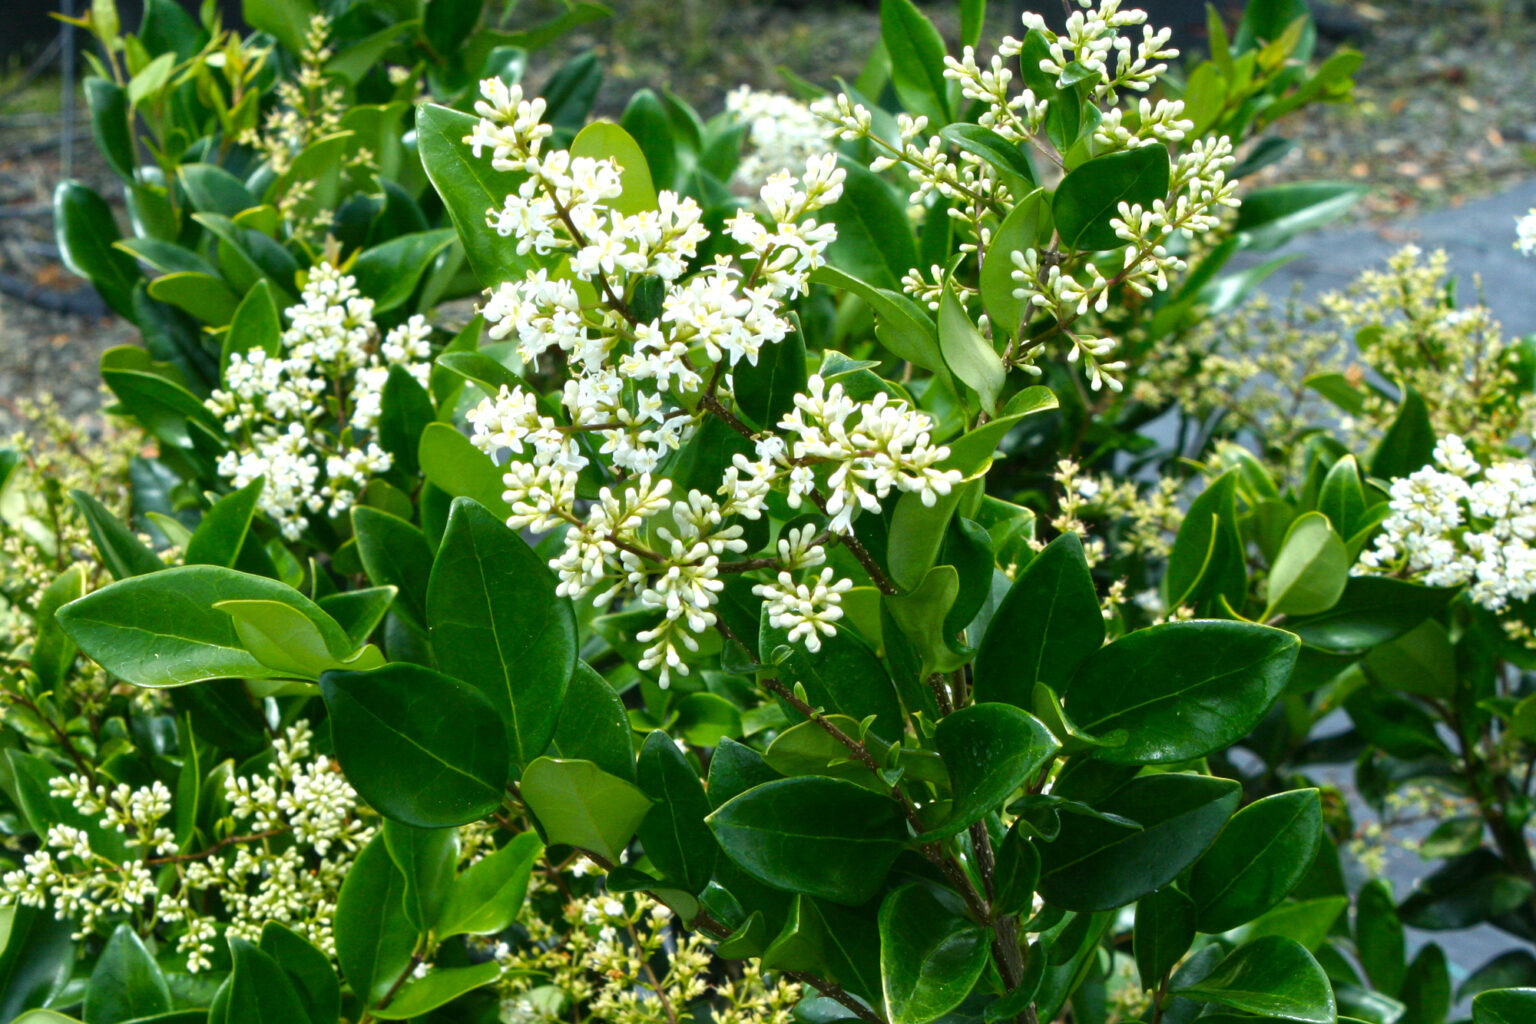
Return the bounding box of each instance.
[204,263,432,540]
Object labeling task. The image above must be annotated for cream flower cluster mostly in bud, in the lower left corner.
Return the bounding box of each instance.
[0,722,372,973]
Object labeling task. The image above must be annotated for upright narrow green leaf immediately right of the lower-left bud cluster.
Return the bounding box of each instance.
[335,835,416,1001]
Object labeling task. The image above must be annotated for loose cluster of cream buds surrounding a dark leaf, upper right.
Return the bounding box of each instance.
[813,0,1238,391]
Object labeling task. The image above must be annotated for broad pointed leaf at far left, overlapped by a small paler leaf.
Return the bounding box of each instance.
[57,565,352,686]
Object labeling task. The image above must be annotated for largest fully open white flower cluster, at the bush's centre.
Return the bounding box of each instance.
[465,80,958,686]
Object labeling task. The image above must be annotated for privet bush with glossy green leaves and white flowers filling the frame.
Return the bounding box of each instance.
[9,0,1536,1024]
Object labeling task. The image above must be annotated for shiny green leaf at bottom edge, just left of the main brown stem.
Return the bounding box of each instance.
[880,883,989,1024]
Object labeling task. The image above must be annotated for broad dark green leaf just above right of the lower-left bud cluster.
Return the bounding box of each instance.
[319,663,507,829]
